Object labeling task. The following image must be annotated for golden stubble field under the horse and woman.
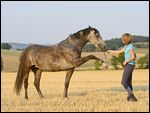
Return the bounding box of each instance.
[1,70,149,112]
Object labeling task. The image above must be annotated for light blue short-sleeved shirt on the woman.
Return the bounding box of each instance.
[124,44,135,65]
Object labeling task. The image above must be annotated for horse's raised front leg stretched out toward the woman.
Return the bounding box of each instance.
[75,55,104,67]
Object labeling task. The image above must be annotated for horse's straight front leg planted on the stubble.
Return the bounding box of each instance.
[63,68,74,98]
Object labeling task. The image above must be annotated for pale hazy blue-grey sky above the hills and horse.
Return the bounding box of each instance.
[1,1,149,44]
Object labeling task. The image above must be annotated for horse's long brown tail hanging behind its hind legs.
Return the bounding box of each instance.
[14,63,25,95]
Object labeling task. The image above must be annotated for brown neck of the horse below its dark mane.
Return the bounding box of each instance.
[60,35,88,52]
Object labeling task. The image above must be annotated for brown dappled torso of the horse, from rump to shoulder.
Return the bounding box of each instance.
[21,45,77,71]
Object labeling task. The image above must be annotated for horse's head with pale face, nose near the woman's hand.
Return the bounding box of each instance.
[87,26,107,51]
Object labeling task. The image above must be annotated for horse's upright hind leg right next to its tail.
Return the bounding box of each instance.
[24,70,29,99]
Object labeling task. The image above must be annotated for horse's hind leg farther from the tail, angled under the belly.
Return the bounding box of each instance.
[32,68,44,98]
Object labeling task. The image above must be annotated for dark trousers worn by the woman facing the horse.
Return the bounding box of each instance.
[121,64,135,92]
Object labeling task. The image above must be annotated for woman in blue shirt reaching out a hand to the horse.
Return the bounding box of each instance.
[107,33,137,101]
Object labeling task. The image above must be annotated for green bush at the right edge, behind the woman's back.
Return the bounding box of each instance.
[137,54,149,69]
